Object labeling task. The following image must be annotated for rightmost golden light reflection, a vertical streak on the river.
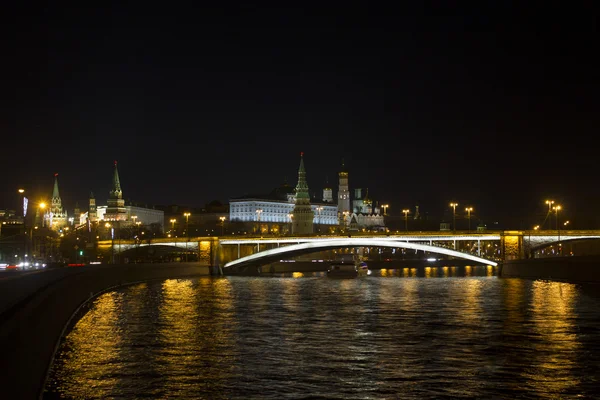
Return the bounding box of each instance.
[523,281,581,396]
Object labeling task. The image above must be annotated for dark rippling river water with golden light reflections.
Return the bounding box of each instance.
[44,267,600,399]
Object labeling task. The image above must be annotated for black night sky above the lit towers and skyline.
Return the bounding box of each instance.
[0,1,600,228]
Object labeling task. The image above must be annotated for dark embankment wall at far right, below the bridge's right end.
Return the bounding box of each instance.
[498,255,600,283]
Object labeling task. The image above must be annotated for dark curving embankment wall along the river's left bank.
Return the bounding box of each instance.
[0,263,210,400]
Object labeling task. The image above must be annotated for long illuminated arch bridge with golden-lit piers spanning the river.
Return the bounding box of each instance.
[99,230,600,269]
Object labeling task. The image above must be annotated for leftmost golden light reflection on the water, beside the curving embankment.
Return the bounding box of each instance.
[54,292,124,399]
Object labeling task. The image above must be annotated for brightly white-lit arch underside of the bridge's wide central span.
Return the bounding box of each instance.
[224,238,498,268]
